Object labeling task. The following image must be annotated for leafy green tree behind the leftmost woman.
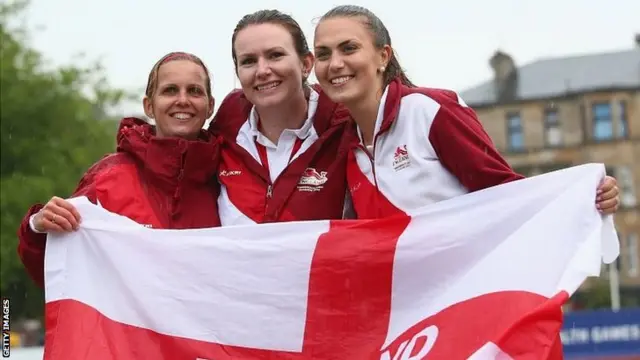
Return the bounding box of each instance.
[0,1,131,318]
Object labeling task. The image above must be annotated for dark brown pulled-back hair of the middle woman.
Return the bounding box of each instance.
[231,10,311,83]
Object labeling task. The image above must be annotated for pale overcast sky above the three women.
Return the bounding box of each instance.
[22,0,640,113]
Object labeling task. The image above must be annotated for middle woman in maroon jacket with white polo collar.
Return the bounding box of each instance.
[210,10,352,226]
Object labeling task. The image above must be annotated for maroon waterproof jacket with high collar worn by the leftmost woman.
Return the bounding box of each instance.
[18,118,220,286]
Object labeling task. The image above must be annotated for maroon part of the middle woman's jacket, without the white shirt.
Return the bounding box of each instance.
[215,85,354,223]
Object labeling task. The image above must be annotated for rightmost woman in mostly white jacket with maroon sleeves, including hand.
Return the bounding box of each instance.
[314,5,619,219]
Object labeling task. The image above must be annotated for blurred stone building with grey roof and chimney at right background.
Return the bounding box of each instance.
[461,35,640,299]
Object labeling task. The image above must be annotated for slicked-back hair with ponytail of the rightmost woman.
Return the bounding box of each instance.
[320,5,415,87]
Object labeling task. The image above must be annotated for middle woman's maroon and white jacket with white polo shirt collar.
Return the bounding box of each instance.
[209,87,355,226]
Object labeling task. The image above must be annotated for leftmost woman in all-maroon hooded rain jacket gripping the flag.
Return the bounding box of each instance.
[18,53,220,286]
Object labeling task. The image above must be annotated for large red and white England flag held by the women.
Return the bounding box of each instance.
[45,164,619,360]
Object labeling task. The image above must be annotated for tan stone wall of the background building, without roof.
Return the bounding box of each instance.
[472,90,640,289]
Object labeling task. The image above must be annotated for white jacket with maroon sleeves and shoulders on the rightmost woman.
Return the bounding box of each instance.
[347,79,522,219]
